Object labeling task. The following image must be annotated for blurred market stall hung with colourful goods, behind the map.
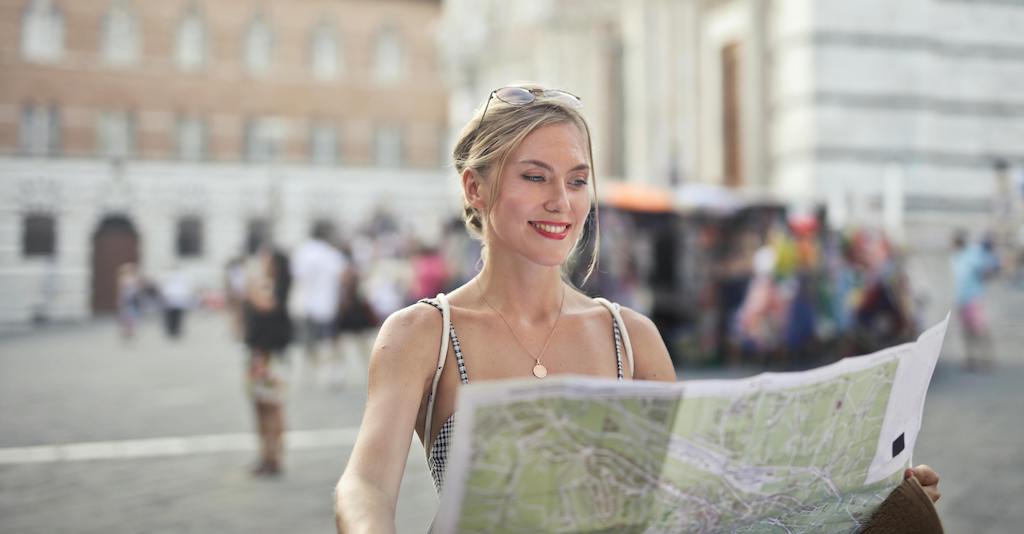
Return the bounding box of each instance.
[592,205,921,368]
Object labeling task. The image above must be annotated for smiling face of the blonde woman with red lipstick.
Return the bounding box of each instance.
[484,123,591,266]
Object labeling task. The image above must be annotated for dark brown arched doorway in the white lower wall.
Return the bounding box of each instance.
[92,215,139,315]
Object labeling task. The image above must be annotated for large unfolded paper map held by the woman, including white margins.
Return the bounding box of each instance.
[434,317,948,534]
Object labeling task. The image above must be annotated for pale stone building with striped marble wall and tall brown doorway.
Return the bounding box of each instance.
[442,0,1024,241]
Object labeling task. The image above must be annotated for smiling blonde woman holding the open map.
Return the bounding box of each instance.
[336,85,932,533]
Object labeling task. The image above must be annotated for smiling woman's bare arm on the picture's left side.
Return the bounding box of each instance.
[335,304,441,533]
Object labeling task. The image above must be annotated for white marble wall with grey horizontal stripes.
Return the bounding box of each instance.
[771,0,1024,231]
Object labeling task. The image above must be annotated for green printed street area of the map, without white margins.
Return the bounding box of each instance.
[458,360,901,533]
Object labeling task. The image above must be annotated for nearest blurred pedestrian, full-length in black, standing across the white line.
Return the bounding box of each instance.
[245,248,293,476]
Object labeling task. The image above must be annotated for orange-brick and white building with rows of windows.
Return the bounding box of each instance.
[0,0,456,323]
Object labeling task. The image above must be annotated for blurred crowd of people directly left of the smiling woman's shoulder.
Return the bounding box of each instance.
[215,212,479,383]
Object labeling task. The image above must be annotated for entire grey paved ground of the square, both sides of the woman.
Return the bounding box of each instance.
[0,258,1024,533]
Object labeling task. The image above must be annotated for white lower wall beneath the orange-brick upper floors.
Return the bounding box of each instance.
[0,158,461,324]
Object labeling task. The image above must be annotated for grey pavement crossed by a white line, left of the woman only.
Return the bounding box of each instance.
[0,315,436,533]
